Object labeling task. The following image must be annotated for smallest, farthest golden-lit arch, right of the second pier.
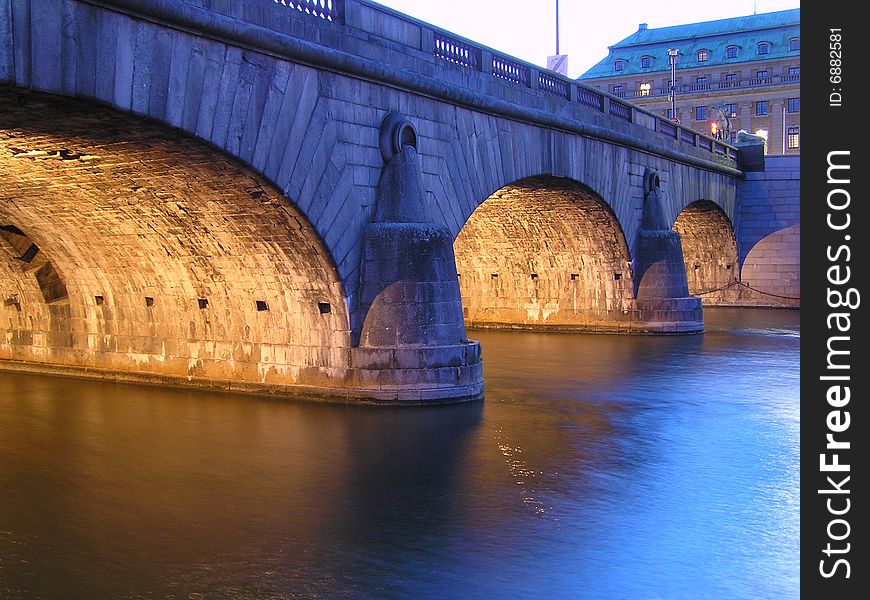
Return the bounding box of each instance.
[673,200,740,305]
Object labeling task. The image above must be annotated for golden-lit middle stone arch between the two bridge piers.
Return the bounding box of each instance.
[454,176,635,330]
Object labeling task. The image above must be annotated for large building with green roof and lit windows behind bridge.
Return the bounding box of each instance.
[579,8,800,154]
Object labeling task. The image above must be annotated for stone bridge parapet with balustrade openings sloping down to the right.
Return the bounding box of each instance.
[165,0,739,175]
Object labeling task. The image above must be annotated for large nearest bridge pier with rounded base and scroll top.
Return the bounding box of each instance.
[352,113,483,403]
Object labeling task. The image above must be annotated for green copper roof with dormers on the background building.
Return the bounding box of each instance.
[578,8,801,80]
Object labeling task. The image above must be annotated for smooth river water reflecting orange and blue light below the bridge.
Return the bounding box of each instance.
[0,309,800,599]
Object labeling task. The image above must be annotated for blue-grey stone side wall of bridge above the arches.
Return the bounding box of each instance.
[0,0,734,329]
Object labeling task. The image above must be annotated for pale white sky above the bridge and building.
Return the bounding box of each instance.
[380,0,800,77]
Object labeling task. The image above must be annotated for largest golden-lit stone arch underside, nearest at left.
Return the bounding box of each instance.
[0,93,350,391]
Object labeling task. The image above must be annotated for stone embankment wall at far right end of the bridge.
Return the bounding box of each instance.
[737,155,801,307]
